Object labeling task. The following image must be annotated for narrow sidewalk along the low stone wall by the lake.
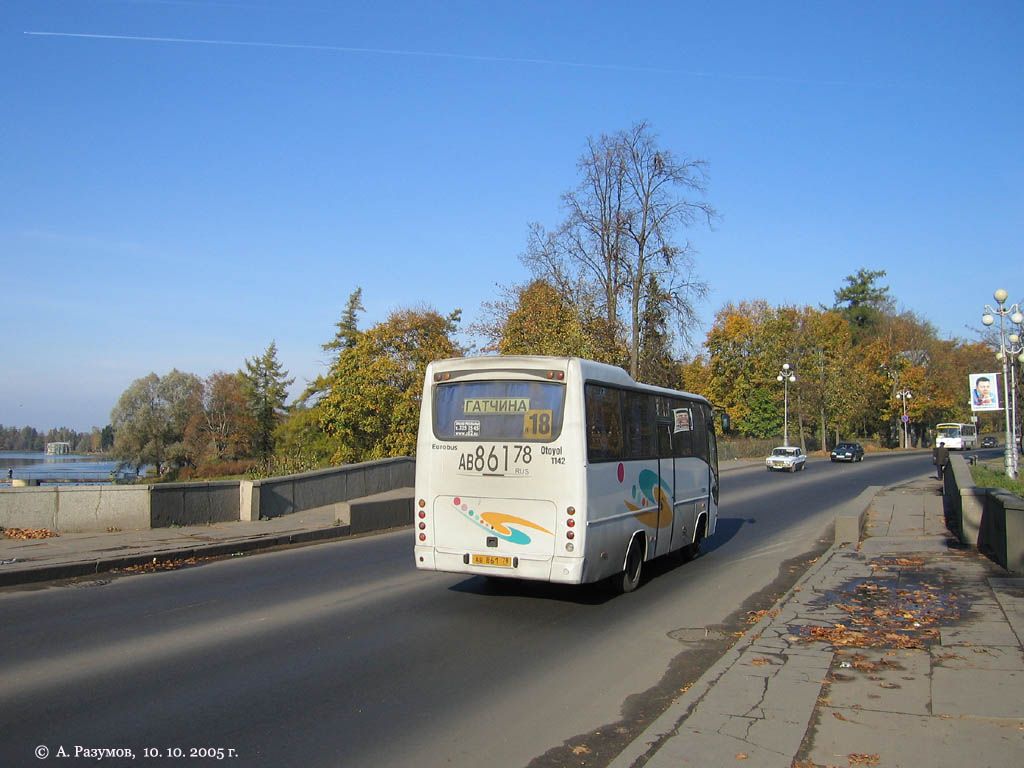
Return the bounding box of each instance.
[0,508,350,587]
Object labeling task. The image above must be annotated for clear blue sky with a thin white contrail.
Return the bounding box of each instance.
[0,0,1024,430]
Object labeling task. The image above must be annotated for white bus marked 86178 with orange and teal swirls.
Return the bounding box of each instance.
[415,356,719,592]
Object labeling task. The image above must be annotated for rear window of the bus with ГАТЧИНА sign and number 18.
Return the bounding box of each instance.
[433,381,565,442]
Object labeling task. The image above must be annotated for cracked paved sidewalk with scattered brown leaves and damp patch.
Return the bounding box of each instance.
[611,477,1024,768]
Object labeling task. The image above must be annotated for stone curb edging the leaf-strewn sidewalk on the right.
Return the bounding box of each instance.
[608,485,884,768]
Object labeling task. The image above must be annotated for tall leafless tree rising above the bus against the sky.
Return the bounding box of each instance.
[523,122,716,377]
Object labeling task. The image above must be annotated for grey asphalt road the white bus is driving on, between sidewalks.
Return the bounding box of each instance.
[0,453,933,768]
